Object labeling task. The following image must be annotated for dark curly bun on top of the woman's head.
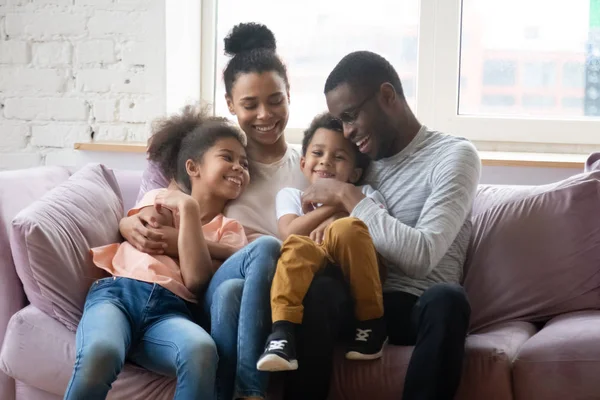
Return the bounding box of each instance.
[225,22,277,56]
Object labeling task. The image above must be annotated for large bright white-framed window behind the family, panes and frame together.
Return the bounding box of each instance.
[165,0,600,151]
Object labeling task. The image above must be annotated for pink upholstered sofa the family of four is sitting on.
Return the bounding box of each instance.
[0,159,600,400]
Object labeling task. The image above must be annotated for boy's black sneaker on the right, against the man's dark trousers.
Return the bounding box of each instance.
[346,318,387,360]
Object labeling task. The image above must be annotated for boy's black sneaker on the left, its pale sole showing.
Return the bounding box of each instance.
[256,331,298,372]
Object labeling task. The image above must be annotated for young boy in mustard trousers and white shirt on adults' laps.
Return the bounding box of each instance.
[257,113,387,371]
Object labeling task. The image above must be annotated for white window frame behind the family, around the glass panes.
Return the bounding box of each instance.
[165,0,600,148]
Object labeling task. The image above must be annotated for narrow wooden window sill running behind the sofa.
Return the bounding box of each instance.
[75,142,588,171]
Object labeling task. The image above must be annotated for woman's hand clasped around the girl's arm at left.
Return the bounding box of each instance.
[119,212,167,254]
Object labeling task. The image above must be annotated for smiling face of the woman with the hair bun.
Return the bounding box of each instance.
[225,71,289,146]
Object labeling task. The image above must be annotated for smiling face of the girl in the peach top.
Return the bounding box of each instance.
[186,137,250,200]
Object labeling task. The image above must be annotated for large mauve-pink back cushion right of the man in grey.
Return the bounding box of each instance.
[464,171,600,330]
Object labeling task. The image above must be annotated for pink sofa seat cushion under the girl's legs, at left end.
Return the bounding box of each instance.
[0,305,175,400]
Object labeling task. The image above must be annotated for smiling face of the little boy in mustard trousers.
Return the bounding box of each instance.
[300,128,362,183]
